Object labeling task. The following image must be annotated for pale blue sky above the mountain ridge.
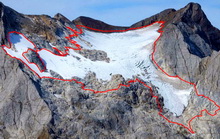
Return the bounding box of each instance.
[1,0,220,28]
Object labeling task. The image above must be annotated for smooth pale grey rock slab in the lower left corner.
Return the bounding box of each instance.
[0,47,51,138]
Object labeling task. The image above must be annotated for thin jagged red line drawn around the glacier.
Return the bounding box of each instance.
[2,21,220,134]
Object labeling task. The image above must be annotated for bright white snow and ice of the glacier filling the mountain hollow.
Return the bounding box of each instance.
[4,23,192,115]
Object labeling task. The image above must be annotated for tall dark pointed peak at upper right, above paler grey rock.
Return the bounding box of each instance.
[180,3,220,51]
